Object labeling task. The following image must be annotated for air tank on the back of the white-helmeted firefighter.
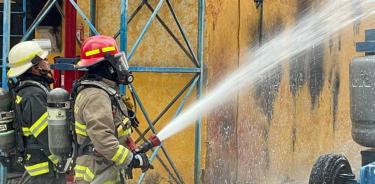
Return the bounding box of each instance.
[0,88,15,152]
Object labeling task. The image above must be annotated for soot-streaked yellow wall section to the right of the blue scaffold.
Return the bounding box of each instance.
[204,0,374,183]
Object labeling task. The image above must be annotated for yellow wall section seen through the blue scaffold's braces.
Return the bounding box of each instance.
[77,0,204,183]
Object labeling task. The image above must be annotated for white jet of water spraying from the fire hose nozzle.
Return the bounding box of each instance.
[157,0,375,141]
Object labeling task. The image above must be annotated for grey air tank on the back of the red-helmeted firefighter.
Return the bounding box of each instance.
[47,88,72,157]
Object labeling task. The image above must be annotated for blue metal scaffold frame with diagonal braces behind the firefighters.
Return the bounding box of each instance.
[0,0,205,184]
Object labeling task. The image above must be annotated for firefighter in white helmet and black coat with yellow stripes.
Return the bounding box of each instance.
[7,41,66,183]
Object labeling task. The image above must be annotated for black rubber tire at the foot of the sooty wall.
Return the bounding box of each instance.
[309,154,354,184]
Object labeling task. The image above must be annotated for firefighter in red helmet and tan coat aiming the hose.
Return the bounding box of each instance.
[73,35,150,184]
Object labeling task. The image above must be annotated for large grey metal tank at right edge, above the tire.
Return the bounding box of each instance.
[349,56,375,147]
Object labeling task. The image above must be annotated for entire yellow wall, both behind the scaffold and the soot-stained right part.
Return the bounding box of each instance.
[60,0,374,183]
